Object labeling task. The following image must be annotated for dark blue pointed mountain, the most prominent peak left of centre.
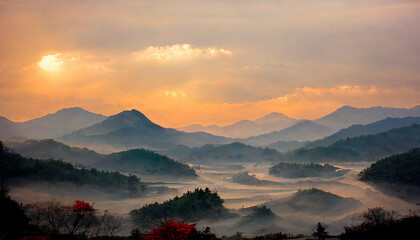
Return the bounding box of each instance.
[61,109,228,149]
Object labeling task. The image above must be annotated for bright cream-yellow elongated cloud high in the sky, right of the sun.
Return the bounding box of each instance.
[132,44,233,62]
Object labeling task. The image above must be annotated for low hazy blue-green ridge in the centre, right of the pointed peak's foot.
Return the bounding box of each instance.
[164,142,281,163]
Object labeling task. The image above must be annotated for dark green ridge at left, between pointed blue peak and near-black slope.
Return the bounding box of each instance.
[6,139,196,178]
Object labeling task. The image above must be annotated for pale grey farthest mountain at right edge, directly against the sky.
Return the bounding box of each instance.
[315,106,420,130]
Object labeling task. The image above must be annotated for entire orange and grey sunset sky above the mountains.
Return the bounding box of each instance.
[0,0,420,127]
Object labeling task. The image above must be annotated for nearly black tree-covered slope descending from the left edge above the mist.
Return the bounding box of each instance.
[0,142,146,193]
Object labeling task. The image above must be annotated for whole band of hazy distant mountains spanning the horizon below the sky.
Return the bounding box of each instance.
[0,106,420,152]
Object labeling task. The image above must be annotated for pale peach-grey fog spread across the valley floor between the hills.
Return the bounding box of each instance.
[10,160,419,236]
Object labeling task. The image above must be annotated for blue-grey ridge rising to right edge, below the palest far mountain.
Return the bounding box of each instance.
[306,117,420,148]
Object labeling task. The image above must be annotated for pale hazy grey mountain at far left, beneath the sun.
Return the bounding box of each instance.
[0,107,106,139]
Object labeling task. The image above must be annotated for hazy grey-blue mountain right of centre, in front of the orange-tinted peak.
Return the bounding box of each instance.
[243,120,333,146]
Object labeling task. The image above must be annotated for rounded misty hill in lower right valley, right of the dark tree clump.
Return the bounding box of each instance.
[263,188,361,216]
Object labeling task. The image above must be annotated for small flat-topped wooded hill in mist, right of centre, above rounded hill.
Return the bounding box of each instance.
[269,163,349,178]
